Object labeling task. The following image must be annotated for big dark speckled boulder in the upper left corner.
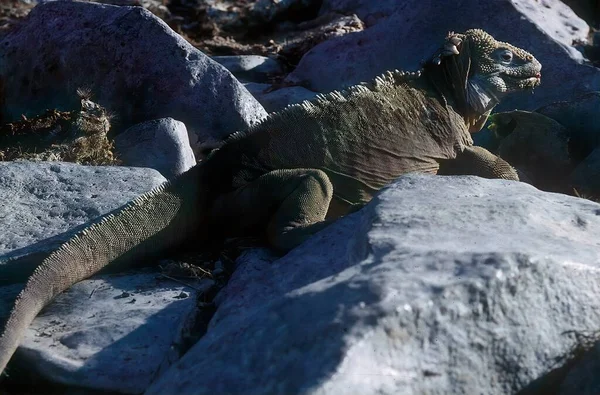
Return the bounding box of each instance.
[0,1,266,145]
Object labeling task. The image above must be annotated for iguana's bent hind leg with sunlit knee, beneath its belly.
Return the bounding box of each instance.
[210,169,333,251]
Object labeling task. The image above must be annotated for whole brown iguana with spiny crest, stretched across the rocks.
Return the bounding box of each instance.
[0,29,541,371]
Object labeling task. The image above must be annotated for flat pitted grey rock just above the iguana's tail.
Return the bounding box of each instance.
[0,162,165,284]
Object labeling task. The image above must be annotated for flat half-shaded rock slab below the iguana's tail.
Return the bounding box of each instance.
[0,272,212,394]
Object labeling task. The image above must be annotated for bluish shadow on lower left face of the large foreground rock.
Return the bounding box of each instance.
[157,276,383,394]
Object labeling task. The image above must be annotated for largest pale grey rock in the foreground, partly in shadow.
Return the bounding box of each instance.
[146,175,600,395]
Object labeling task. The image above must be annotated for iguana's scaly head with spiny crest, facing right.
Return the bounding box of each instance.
[430,29,542,132]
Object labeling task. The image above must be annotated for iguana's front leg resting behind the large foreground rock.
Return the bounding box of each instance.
[437,146,520,181]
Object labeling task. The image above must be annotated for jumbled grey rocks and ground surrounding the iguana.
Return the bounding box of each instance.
[0,0,600,395]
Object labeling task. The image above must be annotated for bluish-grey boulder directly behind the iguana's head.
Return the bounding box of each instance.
[287,0,600,111]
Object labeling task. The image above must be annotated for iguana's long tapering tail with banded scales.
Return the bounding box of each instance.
[0,165,204,372]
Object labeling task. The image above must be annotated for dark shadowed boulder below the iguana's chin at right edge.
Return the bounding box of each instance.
[476,92,600,199]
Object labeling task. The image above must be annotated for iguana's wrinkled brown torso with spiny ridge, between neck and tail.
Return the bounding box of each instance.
[207,71,473,213]
